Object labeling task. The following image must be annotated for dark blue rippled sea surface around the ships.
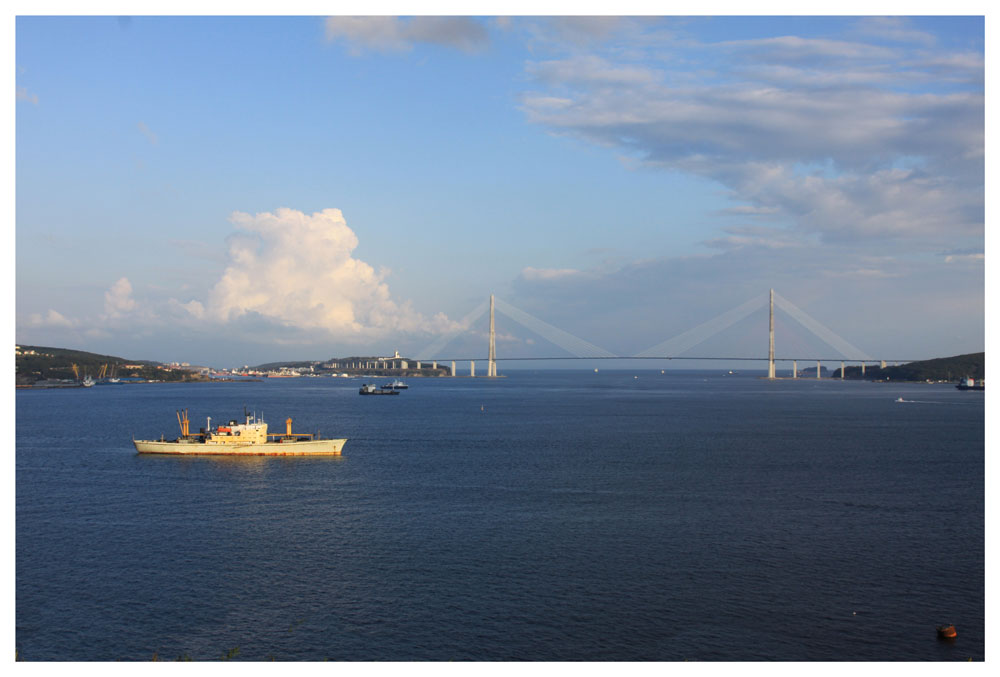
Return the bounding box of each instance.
[16,370,984,661]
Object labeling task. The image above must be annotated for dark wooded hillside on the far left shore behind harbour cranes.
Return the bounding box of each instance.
[14,345,202,385]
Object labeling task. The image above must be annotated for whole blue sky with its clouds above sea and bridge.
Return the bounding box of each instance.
[14,10,986,367]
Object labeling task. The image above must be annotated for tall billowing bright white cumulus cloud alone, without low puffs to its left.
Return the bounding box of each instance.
[207,208,449,338]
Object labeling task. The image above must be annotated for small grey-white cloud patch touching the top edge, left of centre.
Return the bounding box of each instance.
[326,16,489,54]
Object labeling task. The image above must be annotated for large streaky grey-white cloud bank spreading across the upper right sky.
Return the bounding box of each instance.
[521,25,985,251]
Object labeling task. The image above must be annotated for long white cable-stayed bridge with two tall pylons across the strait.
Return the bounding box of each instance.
[417,289,913,378]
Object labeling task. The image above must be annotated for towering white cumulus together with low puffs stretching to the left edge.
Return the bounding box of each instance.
[18,208,457,350]
